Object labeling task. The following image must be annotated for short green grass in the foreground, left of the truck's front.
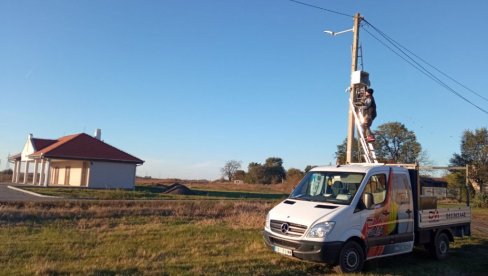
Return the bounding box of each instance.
[0,218,324,275]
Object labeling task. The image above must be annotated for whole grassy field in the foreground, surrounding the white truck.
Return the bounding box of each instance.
[0,200,488,275]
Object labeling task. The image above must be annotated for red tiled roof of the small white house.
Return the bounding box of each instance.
[30,133,144,164]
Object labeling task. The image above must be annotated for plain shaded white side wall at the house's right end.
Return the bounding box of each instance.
[88,161,136,189]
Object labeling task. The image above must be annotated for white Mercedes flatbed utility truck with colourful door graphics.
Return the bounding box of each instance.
[263,163,471,272]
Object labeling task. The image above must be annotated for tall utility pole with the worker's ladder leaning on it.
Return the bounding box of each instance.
[346,13,362,164]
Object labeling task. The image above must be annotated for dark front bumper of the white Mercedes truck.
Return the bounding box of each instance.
[263,231,344,265]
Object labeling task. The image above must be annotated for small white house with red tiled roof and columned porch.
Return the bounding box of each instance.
[9,129,144,189]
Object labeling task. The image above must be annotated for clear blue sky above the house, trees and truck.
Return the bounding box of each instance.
[0,0,488,179]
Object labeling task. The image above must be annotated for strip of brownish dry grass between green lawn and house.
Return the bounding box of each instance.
[0,200,274,227]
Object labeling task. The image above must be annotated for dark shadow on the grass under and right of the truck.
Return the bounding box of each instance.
[363,240,488,275]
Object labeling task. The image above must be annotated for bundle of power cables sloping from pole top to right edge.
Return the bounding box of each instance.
[363,19,488,114]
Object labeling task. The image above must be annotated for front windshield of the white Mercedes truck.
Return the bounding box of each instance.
[290,172,364,205]
